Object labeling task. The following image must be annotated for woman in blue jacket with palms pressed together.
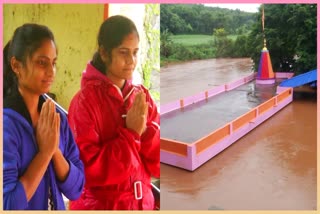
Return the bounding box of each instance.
[3,24,84,210]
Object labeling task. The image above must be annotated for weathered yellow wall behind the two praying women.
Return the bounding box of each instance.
[3,4,104,110]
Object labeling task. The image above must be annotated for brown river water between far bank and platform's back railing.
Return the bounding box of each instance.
[160,58,252,105]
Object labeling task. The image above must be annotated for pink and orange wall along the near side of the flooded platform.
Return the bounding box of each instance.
[160,86,293,171]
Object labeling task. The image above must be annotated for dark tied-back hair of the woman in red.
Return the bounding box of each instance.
[91,15,139,74]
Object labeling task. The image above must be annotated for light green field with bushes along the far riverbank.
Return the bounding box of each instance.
[160,31,249,66]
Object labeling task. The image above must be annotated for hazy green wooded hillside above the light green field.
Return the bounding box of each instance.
[160,4,254,35]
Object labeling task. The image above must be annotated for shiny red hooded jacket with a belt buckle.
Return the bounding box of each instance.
[68,63,160,210]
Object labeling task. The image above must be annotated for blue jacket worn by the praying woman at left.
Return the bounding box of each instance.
[3,90,84,210]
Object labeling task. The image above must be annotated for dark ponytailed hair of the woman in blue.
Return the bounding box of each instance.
[3,24,54,98]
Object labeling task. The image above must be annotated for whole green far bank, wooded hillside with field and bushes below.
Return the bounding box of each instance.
[160,4,255,66]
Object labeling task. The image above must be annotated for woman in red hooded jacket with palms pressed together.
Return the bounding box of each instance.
[68,16,160,210]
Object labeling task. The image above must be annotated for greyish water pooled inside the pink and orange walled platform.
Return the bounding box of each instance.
[161,81,277,143]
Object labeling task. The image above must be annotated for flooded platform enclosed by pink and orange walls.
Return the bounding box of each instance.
[160,73,293,171]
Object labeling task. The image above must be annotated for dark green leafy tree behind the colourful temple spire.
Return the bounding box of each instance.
[248,4,317,74]
